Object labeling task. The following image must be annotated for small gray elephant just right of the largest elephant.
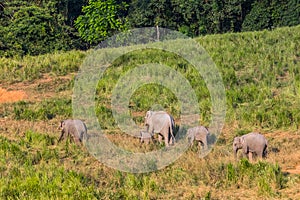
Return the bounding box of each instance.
[186,126,209,151]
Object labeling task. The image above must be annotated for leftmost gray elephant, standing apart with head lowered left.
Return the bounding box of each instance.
[58,119,87,144]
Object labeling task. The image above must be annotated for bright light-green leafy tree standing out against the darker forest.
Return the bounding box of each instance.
[75,0,127,44]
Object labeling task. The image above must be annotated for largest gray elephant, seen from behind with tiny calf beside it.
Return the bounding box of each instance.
[145,111,175,147]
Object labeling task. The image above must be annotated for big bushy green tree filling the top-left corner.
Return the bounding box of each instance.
[0,0,88,57]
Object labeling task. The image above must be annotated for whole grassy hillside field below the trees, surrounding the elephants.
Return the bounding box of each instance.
[0,26,300,199]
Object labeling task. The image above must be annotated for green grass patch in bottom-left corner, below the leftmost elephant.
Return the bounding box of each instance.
[0,131,100,199]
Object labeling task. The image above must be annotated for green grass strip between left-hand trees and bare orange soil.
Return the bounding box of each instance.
[0,51,86,83]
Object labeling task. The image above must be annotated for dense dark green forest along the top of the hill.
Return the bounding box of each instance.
[0,0,300,56]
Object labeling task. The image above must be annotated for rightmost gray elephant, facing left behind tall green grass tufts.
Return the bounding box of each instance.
[233,132,268,162]
